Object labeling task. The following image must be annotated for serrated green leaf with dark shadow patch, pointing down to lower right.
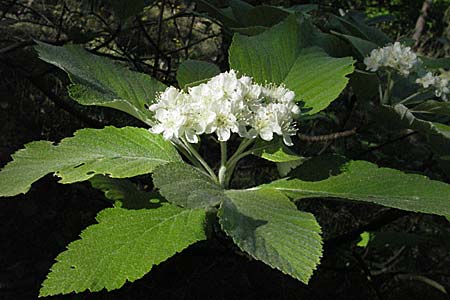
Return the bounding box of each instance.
[219,190,322,283]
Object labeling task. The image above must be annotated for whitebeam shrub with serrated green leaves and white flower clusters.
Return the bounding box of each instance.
[0,14,450,297]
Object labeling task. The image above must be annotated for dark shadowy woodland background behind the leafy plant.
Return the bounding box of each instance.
[0,0,450,299]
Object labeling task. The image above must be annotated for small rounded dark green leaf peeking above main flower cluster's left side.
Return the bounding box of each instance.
[177,59,220,88]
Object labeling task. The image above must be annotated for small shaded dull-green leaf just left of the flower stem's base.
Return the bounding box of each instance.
[153,162,225,208]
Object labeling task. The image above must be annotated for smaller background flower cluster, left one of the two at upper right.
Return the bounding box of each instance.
[364,42,418,76]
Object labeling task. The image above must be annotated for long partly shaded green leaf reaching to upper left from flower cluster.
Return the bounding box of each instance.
[35,42,165,124]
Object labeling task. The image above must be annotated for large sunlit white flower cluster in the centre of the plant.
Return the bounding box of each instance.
[150,70,300,146]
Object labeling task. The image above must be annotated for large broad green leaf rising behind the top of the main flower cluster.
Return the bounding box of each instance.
[230,16,354,114]
